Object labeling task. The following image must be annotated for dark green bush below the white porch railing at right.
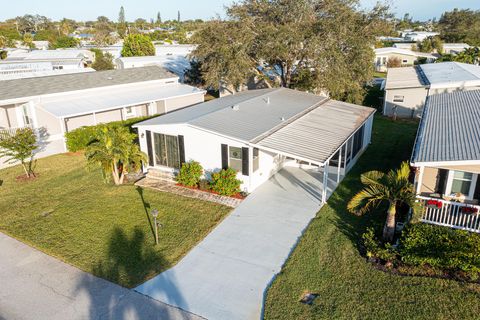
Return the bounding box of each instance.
[400,224,480,277]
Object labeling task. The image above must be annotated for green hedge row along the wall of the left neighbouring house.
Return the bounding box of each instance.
[65,116,152,152]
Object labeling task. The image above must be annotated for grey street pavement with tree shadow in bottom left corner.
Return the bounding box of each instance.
[0,233,201,320]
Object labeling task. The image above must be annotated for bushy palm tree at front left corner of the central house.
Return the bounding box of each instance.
[85,125,147,185]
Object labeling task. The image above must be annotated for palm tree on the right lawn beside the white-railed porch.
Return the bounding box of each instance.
[347,162,415,241]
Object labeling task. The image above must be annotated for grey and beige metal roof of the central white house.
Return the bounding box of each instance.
[136,88,375,163]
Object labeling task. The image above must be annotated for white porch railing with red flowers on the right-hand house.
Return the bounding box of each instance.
[417,196,480,233]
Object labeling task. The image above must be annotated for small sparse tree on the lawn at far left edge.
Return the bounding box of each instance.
[0,128,38,178]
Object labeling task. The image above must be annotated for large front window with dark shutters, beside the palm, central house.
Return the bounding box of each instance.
[153,133,180,169]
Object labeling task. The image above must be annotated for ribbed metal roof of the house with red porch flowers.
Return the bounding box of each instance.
[412,90,480,163]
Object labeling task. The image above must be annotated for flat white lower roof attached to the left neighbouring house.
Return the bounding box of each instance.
[41,83,205,118]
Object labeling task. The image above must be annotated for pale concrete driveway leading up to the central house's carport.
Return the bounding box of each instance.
[136,168,322,320]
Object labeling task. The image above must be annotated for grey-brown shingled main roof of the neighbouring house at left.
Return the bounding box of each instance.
[0,66,177,101]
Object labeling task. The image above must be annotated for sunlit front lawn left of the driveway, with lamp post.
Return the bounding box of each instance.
[0,154,230,287]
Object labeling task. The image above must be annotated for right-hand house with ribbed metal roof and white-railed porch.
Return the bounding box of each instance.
[411,90,480,233]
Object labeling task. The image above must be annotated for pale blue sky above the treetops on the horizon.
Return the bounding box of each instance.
[0,0,480,21]
